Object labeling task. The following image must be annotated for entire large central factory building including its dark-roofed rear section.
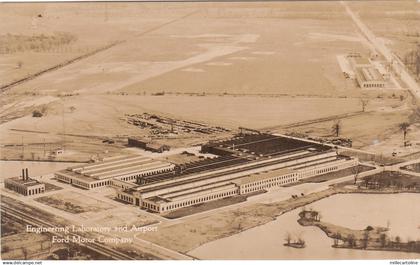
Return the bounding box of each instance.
[117,134,358,213]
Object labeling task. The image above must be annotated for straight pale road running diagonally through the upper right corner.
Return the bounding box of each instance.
[341,1,420,100]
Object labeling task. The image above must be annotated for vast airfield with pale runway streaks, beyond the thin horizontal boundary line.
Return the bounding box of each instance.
[0,2,367,95]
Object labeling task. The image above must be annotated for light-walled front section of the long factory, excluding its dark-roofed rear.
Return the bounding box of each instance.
[117,148,358,213]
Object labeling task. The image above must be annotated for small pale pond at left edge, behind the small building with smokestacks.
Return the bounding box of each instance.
[0,161,81,181]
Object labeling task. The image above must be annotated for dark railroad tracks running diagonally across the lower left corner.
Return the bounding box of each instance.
[1,203,135,260]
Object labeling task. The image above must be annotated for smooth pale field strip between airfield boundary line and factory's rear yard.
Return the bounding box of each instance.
[0,95,360,140]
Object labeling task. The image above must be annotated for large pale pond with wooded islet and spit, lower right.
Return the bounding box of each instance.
[189,194,420,259]
